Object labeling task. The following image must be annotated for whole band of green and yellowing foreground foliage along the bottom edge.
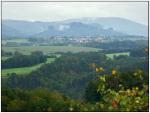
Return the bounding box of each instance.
[2,70,149,111]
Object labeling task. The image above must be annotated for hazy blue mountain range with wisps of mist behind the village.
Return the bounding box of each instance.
[2,17,148,38]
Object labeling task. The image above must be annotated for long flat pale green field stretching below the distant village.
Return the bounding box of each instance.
[2,46,100,54]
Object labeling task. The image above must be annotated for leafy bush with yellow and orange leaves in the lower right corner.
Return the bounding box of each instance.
[97,70,149,111]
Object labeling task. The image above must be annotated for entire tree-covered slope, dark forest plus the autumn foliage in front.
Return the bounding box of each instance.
[2,48,149,111]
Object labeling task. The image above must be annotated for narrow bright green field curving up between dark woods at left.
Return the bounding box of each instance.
[1,58,55,76]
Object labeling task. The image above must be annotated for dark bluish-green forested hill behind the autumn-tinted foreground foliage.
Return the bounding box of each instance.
[2,52,148,99]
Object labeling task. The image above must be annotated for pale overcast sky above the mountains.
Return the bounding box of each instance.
[2,2,148,25]
